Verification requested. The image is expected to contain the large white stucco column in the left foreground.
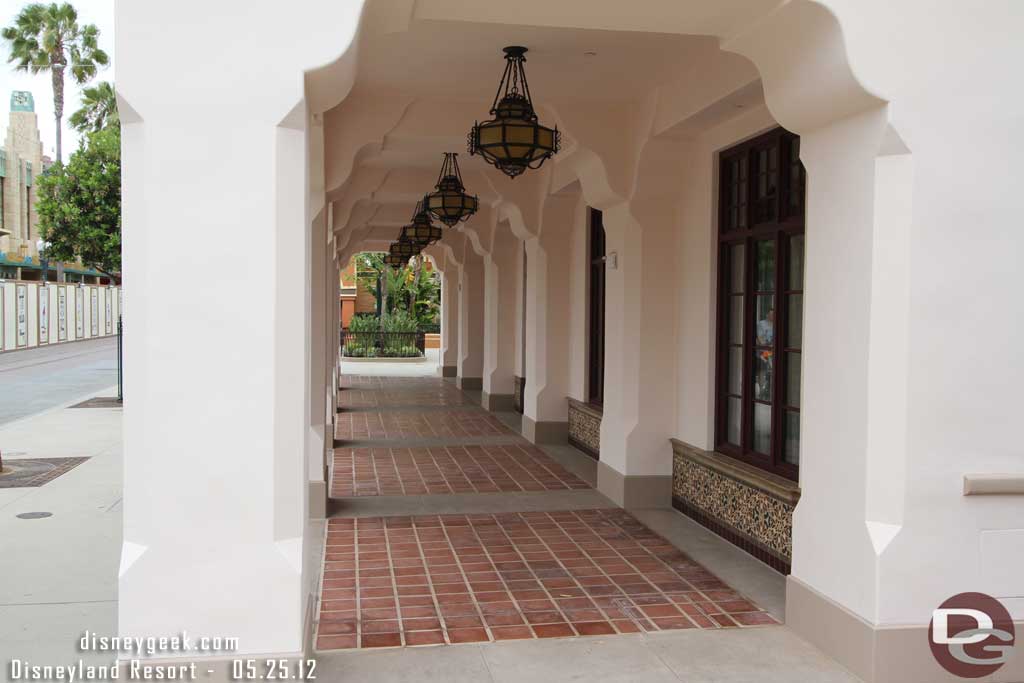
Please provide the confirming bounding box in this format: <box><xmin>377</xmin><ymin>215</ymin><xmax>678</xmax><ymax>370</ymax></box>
<box><xmin>116</xmin><ymin>0</ymin><xmax>358</xmax><ymax>656</ymax></box>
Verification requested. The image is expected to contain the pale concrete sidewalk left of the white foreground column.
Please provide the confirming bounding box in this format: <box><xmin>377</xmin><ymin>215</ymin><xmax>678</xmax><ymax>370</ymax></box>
<box><xmin>0</xmin><ymin>387</ymin><xmax>122</xmax><ymax>680</ymax></box>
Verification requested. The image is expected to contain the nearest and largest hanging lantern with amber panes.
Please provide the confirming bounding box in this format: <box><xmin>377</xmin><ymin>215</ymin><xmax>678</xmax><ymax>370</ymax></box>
<box><xmin>469</xmin><ymin>45</ymin><xmax>561</xmax><ymax>178</ymax></box>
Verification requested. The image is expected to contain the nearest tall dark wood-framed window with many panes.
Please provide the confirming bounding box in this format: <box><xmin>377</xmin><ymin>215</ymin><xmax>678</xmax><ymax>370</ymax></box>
<box><xmin>715</xmin><ymin>128</ymin><xmax>806</xmax><ymax>480</ymax></box>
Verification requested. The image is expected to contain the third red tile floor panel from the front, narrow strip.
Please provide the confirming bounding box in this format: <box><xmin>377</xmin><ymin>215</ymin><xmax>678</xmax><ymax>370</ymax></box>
<box><xmin>334</xmin><ymin>408</ymin><xmax>512</xmax><ymax>440</ymax></box>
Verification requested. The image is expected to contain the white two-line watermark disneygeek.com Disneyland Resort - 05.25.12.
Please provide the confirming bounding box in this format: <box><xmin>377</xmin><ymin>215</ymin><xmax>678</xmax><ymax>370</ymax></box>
<box><xmin>6</xmin><ymin>631</ymin><xmax>316</xmax><ymax>683</ymax></box>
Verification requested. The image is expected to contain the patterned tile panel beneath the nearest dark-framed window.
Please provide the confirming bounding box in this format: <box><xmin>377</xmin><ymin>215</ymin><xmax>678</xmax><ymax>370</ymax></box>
<box><xmin>671</xmin><ymin>440</ymin><xmax>800</xmax><ymax>573</ymax></box>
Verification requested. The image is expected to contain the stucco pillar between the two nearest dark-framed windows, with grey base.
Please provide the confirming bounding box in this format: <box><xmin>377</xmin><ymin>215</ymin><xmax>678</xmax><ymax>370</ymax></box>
<box><xmin>598</xmin><ymin>201</ymin><xmax>677</xmax><ymax>507</ymax></box>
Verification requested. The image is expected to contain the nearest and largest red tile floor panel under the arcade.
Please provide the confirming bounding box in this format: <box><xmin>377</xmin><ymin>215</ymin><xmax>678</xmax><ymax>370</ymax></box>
<box><xmin>316</xmin><ymin>509</ymin><xmax>776</xmax><ymax>650</ymax></box>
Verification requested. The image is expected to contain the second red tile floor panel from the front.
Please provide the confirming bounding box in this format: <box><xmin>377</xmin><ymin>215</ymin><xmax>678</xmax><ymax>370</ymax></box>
<box><xmin>331</xmin><ymin>443</ymin><xmax>590</xmax><ymax>498</ymax></box>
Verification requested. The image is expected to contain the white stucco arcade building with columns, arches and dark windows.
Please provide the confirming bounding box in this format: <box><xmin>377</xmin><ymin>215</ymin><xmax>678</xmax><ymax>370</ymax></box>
<box><xmin>117</xmin><ymin>0</ymin><xmax>1024</xmax><ymax>681</ymax></box>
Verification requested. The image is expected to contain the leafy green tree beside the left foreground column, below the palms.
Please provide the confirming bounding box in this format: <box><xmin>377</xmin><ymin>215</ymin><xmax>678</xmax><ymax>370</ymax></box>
<box><xmin>37</xmin><ymin>126</ymin><xmax>121</xmax><ymax>278</ymax></box>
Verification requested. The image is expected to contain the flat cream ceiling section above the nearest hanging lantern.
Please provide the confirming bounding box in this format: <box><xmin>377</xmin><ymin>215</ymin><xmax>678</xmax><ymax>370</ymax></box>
<box><xmin>356</xmin><ymin>20</ymin><xmax>718</xmax><ymax>102</ymax></box>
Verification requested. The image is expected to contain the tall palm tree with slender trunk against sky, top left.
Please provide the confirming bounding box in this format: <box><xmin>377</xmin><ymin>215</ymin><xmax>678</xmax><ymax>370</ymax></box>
<box><xmin>0</xmin><ymin>2</ymin><xmax>109</xmax><ymax>163</ymax></box>
